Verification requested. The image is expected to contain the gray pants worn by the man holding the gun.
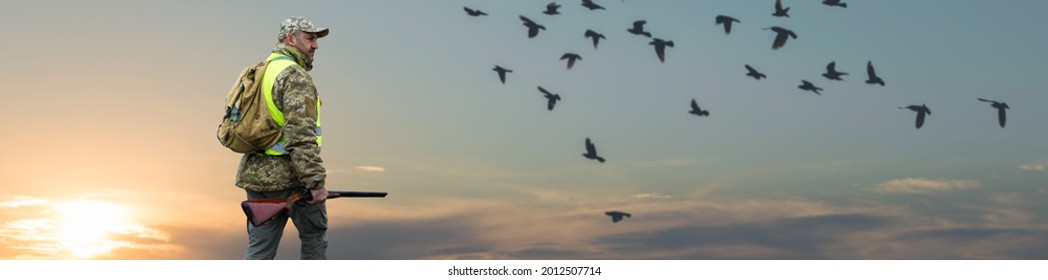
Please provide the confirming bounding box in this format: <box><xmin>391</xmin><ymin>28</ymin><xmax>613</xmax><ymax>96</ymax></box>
<box><xmin>244</xmin><ymin>190</ymin><xmax>327</xmax><ymax>260</ymax></box>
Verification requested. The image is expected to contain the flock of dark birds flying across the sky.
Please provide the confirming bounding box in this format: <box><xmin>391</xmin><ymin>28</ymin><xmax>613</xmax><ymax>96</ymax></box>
<box><xmin>463</xmin><ymin>0</ymin><xmax>1009</xmax><ymax>222</ymax></box>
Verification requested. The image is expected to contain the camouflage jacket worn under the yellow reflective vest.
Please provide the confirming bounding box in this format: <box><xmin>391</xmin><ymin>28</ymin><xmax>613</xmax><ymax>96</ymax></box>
<box><xmin>236</xmin><ymin>43</ymin><xmax>327</xmax><ymax>192</ymax></box>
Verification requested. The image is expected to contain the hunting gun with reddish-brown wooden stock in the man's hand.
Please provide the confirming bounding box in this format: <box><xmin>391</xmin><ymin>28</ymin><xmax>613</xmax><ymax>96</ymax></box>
<box><xmin>240</xmin><ymin>189</ymin><xmax>387</xmax><ymax>227</ymax></box>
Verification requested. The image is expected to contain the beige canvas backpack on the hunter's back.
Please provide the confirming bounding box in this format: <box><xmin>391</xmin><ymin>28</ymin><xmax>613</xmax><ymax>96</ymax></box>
<box><xmin>218</xmin><ymin>61</ymin><xmax>280</xmax><ymax>153</ymax></box>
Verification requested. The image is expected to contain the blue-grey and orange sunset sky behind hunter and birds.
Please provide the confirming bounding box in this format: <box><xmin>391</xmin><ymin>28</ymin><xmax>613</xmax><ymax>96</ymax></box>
<box><xmin>0</xmin><ymin>0</ymin><xmax>1048</xmax><ymax>260</ymax></box>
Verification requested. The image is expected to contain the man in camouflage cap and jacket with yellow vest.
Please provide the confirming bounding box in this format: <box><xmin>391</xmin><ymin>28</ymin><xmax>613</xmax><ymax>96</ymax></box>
<box><xmin>236</xmin><ymin>17</ymin><xmax>329</xmax><ymax>259</ymax></box>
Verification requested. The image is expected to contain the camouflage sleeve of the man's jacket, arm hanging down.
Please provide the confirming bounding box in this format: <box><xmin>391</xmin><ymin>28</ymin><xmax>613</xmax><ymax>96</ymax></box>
<box><xmin>277</xmin><ymin>66</ymin><xmax>327</xmax><ymax>188</ymax></box>
